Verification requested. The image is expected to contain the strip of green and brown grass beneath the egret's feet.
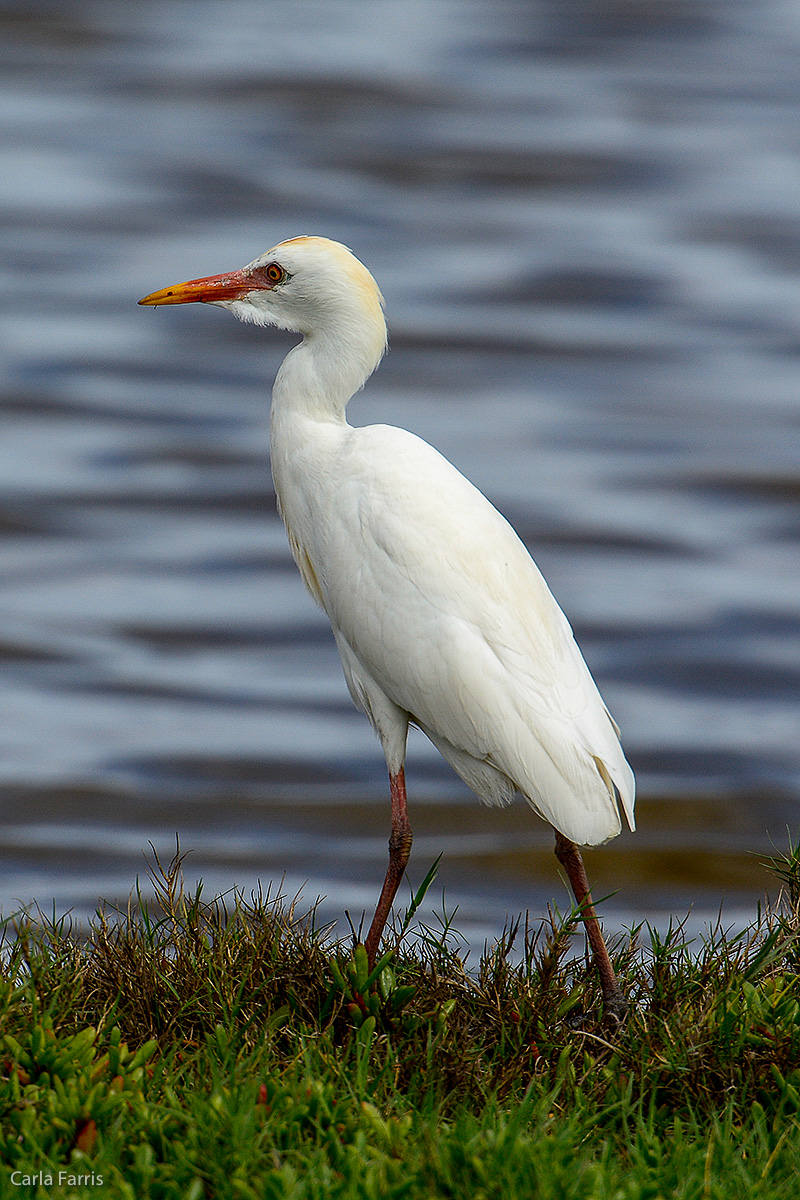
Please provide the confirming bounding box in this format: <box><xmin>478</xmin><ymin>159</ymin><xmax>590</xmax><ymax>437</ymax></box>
<box><xmin>0</xmin><ymin>852</ymin><xmax>800</xmax><ymax>1200</ymax></box>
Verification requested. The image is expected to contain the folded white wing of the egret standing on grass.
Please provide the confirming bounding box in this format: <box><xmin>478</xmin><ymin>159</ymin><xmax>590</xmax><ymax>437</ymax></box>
<box><xmin>309</xmin><ymin>426</ymin><xmax>632</xmax><ymax>842</ymax></box>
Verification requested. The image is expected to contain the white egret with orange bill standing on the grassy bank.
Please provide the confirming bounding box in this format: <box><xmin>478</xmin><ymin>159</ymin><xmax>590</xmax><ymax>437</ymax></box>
<box><xmin>139</xmin><ymin>238</ymin><xmax>634</xmax><ymax>1016</ymax></box>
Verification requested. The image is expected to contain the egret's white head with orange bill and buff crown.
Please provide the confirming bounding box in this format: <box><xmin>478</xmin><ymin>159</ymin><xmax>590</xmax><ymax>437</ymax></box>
<box><xmin>139</xmin><ymin>238</ymin><xmax>386</xmax><ymax>358</ymax></box>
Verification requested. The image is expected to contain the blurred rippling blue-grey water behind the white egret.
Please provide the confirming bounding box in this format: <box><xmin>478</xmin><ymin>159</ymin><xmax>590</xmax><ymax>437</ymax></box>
<box><xmin>0</xmin><ymin>0</ymin><xmax>800</xmax><ymax>947</ymax></box>
